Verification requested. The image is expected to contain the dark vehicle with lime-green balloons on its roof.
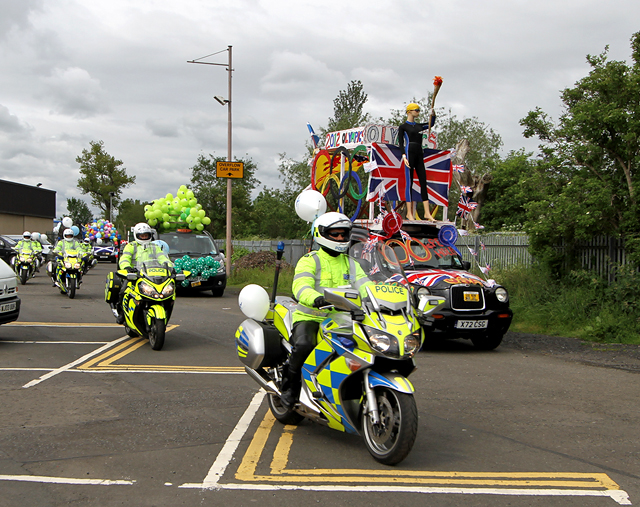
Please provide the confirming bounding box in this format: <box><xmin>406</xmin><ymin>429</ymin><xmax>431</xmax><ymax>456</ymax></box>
<box><xmin>158</xmin><ymin>229</ymin><xmax>227</xmax><ymax>297</ymax></box>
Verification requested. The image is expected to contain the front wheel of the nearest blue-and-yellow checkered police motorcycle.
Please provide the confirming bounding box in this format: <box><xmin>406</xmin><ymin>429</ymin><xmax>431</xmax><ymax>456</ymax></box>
<box><xmin>362</xmin><ymin>387</ymin><xmax>418</xmax><ymax>465</ymax></box>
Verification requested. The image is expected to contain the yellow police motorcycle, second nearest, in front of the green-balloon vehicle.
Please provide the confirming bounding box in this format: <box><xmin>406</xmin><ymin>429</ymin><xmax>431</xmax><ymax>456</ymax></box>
<box><xmin>105</xmin><ymin>259</ymin><xmax>190</xmax><ymax>350</ymax></box>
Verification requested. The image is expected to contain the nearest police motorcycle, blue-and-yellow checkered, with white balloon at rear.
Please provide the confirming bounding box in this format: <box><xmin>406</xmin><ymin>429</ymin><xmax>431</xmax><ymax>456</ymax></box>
<box><xmin>235</xmin><ymin>242</ymin><xmax>445</xmax><ymax>465</ymax></box>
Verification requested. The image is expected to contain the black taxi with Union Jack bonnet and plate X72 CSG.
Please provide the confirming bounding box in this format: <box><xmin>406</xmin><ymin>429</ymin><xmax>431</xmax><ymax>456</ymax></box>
<box><xmin>356</xmin><ymin>222</ymin><xmax>513</xmax><ymax>350</ymax></box>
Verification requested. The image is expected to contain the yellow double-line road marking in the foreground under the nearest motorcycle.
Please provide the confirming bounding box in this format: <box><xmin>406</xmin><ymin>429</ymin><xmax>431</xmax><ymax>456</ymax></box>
<box><xmin>236</xmin><ymin>412</ymin><xmax>620</xmax><ymax>490</ymax></box>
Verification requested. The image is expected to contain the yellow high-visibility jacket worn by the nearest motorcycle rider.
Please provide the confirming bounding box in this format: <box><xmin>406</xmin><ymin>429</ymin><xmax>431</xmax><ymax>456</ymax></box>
<box><xmin>292</xmin><ymin>249</ymin><xmax>373</xmax><ymax>324</ymax></box>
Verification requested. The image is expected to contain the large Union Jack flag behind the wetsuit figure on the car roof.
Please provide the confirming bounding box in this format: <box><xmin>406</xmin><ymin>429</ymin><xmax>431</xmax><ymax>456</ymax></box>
<box><xmin>367</xmin><ymin>143</ymin><xmax>451</xmax><ymax>206</ymax></box>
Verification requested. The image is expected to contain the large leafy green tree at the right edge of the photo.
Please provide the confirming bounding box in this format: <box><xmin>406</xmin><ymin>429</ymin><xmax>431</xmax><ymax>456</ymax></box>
<box><xmin>520</xmin><ymin>32</ymin><xmax>640</xmax><ymax>260</ymax></box>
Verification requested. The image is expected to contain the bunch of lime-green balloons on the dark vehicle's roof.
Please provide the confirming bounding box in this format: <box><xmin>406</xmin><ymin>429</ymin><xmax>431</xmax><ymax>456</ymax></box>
<box><xmin>144</xmin><ymin>185</ymin><xmax>211</xmax><ymax>232</ymax></box>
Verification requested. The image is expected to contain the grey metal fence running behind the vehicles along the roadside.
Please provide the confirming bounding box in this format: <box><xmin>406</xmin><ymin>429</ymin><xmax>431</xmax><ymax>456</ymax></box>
<box><xmin>224</xmin><ymin>232</ymin><xmax>628</xmax><ymax>277</ymax></box>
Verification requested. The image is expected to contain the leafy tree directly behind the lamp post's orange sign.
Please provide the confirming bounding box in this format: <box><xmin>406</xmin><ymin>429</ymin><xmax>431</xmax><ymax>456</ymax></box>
<box><xmin>191</xmin><ymin>155</ymin><xmax>260</xmax><ymax>238</ymax></box>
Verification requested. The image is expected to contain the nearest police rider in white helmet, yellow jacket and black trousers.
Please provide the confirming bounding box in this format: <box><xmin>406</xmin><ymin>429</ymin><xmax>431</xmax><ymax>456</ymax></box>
<box><xmin>281</xmin><ymin>212</ymin><xmax>371</xmax><ymax>409</ymax></box>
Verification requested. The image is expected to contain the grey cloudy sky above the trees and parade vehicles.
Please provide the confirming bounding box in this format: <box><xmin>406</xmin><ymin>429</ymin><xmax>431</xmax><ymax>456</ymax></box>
<box><xmin>0</xmin><ymin>0</ymin><xmax>640</xmax><ymax>214</ymax></box>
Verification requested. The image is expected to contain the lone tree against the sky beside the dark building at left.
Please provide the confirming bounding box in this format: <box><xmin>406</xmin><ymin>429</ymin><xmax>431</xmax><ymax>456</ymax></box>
<box><xmin>76</xmin><ymin>141</ymin><xmax>136</xmax><ymax>219</ymax></box>
